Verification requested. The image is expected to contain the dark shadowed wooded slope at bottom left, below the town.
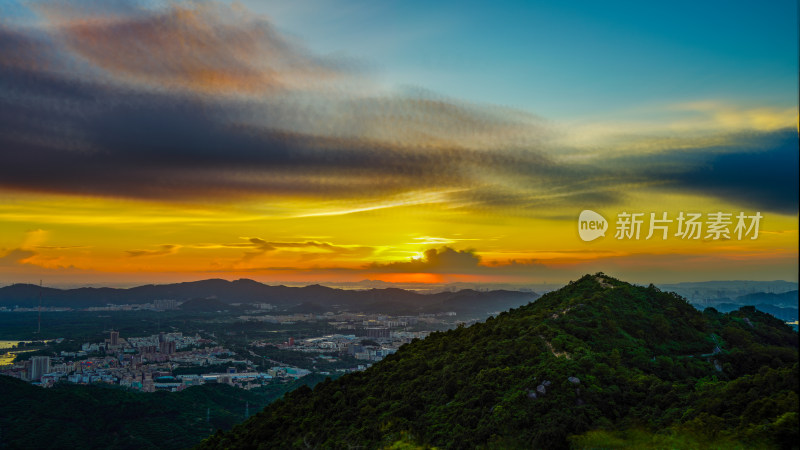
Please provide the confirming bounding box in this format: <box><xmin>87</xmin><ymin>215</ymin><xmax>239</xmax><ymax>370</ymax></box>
<box><xmin>0</xmin><ymin>375</ymin><xmax>328</xmax><ymax>449</ymax></box>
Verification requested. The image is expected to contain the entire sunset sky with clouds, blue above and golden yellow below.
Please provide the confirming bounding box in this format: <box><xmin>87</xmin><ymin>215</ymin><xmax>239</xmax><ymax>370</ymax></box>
<box><xmin>0</xmin><ymin>0</ymin><xmax>798</xmax><ymax>286</ymax></box>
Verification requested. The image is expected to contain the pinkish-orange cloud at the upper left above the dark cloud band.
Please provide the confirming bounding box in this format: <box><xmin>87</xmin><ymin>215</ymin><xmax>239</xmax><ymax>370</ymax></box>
<box><xmin>35</xmin><ymin>2</ymin><xmax>340</xmax><ymax>94</ymax></box>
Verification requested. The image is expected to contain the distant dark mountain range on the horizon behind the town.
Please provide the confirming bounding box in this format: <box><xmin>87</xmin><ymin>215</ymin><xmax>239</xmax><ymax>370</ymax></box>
<box><xmin>0</xmin><ymin>279</ymin><xmax>539</xmax><ymax>314</ymax></box>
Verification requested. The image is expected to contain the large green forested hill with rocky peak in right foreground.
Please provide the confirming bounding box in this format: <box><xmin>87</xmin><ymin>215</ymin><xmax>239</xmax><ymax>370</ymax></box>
<box><xmin>203</xmin><ymin>274</ymin><xmax>798</xmax><ymax>448</ymax></box>
